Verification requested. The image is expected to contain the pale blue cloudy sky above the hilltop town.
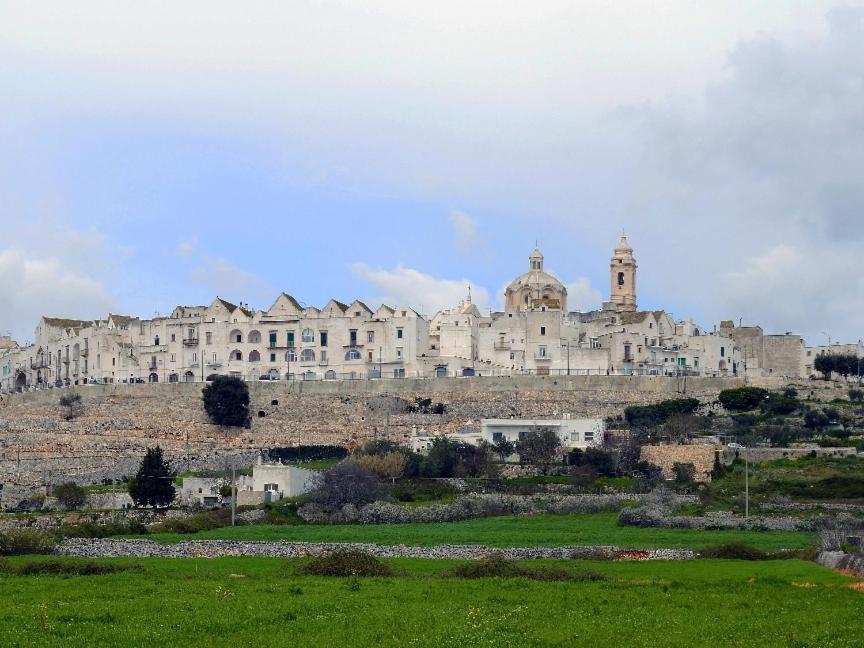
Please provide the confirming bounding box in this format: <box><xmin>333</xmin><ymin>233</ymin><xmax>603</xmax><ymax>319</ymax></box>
<box><xmin>0</xmin><ymin>0</ymin><xmax>864</xmax><ymax>344</ymax></box>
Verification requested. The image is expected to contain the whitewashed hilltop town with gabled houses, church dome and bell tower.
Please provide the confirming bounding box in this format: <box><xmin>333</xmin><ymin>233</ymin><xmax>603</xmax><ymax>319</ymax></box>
<box><xmin>0</xmin><ymin>236</ymin><xmax>858</xmax><ymax>392</ymax></box>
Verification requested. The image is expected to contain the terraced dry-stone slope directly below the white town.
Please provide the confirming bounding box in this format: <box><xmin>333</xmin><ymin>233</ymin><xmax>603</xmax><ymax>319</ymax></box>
<box><xmin>0</xmin><ymin>376</ymin><xmax>738</xmax><ymax>505</ymax></box>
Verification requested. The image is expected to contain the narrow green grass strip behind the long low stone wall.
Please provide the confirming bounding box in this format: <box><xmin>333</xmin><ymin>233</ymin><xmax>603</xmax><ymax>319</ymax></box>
<box><xmin>138</xmin><ymin>513</ymin><xmax>815</xmax><ymax>551</ymax></box>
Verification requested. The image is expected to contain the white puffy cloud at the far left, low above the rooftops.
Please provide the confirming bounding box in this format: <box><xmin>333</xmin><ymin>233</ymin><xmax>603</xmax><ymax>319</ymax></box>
<box><xmin>0</xmin><ymin>249</ymin><xmax>115</xmax><ymax>344</ymax></box>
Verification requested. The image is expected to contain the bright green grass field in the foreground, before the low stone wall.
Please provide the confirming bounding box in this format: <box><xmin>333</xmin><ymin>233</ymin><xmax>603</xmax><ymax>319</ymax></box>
<box><xmin>0</xmin><ymin>558</ymin><xmax>864</xmax><ymax>648</ymax></box>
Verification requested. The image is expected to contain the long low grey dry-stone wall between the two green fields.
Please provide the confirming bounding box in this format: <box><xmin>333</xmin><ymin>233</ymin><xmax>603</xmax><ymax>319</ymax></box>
<box><xmin>55</xmin><ymin>538</ymin><xmax>696</xmax><ymax>560</ymax></box>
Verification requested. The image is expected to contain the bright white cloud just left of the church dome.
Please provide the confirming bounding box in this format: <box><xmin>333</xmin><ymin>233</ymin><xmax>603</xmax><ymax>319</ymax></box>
<box><xmin>351</xmin><ymin>263</ymin><xmax>490</xmax><ymax>315</ymax></box>
